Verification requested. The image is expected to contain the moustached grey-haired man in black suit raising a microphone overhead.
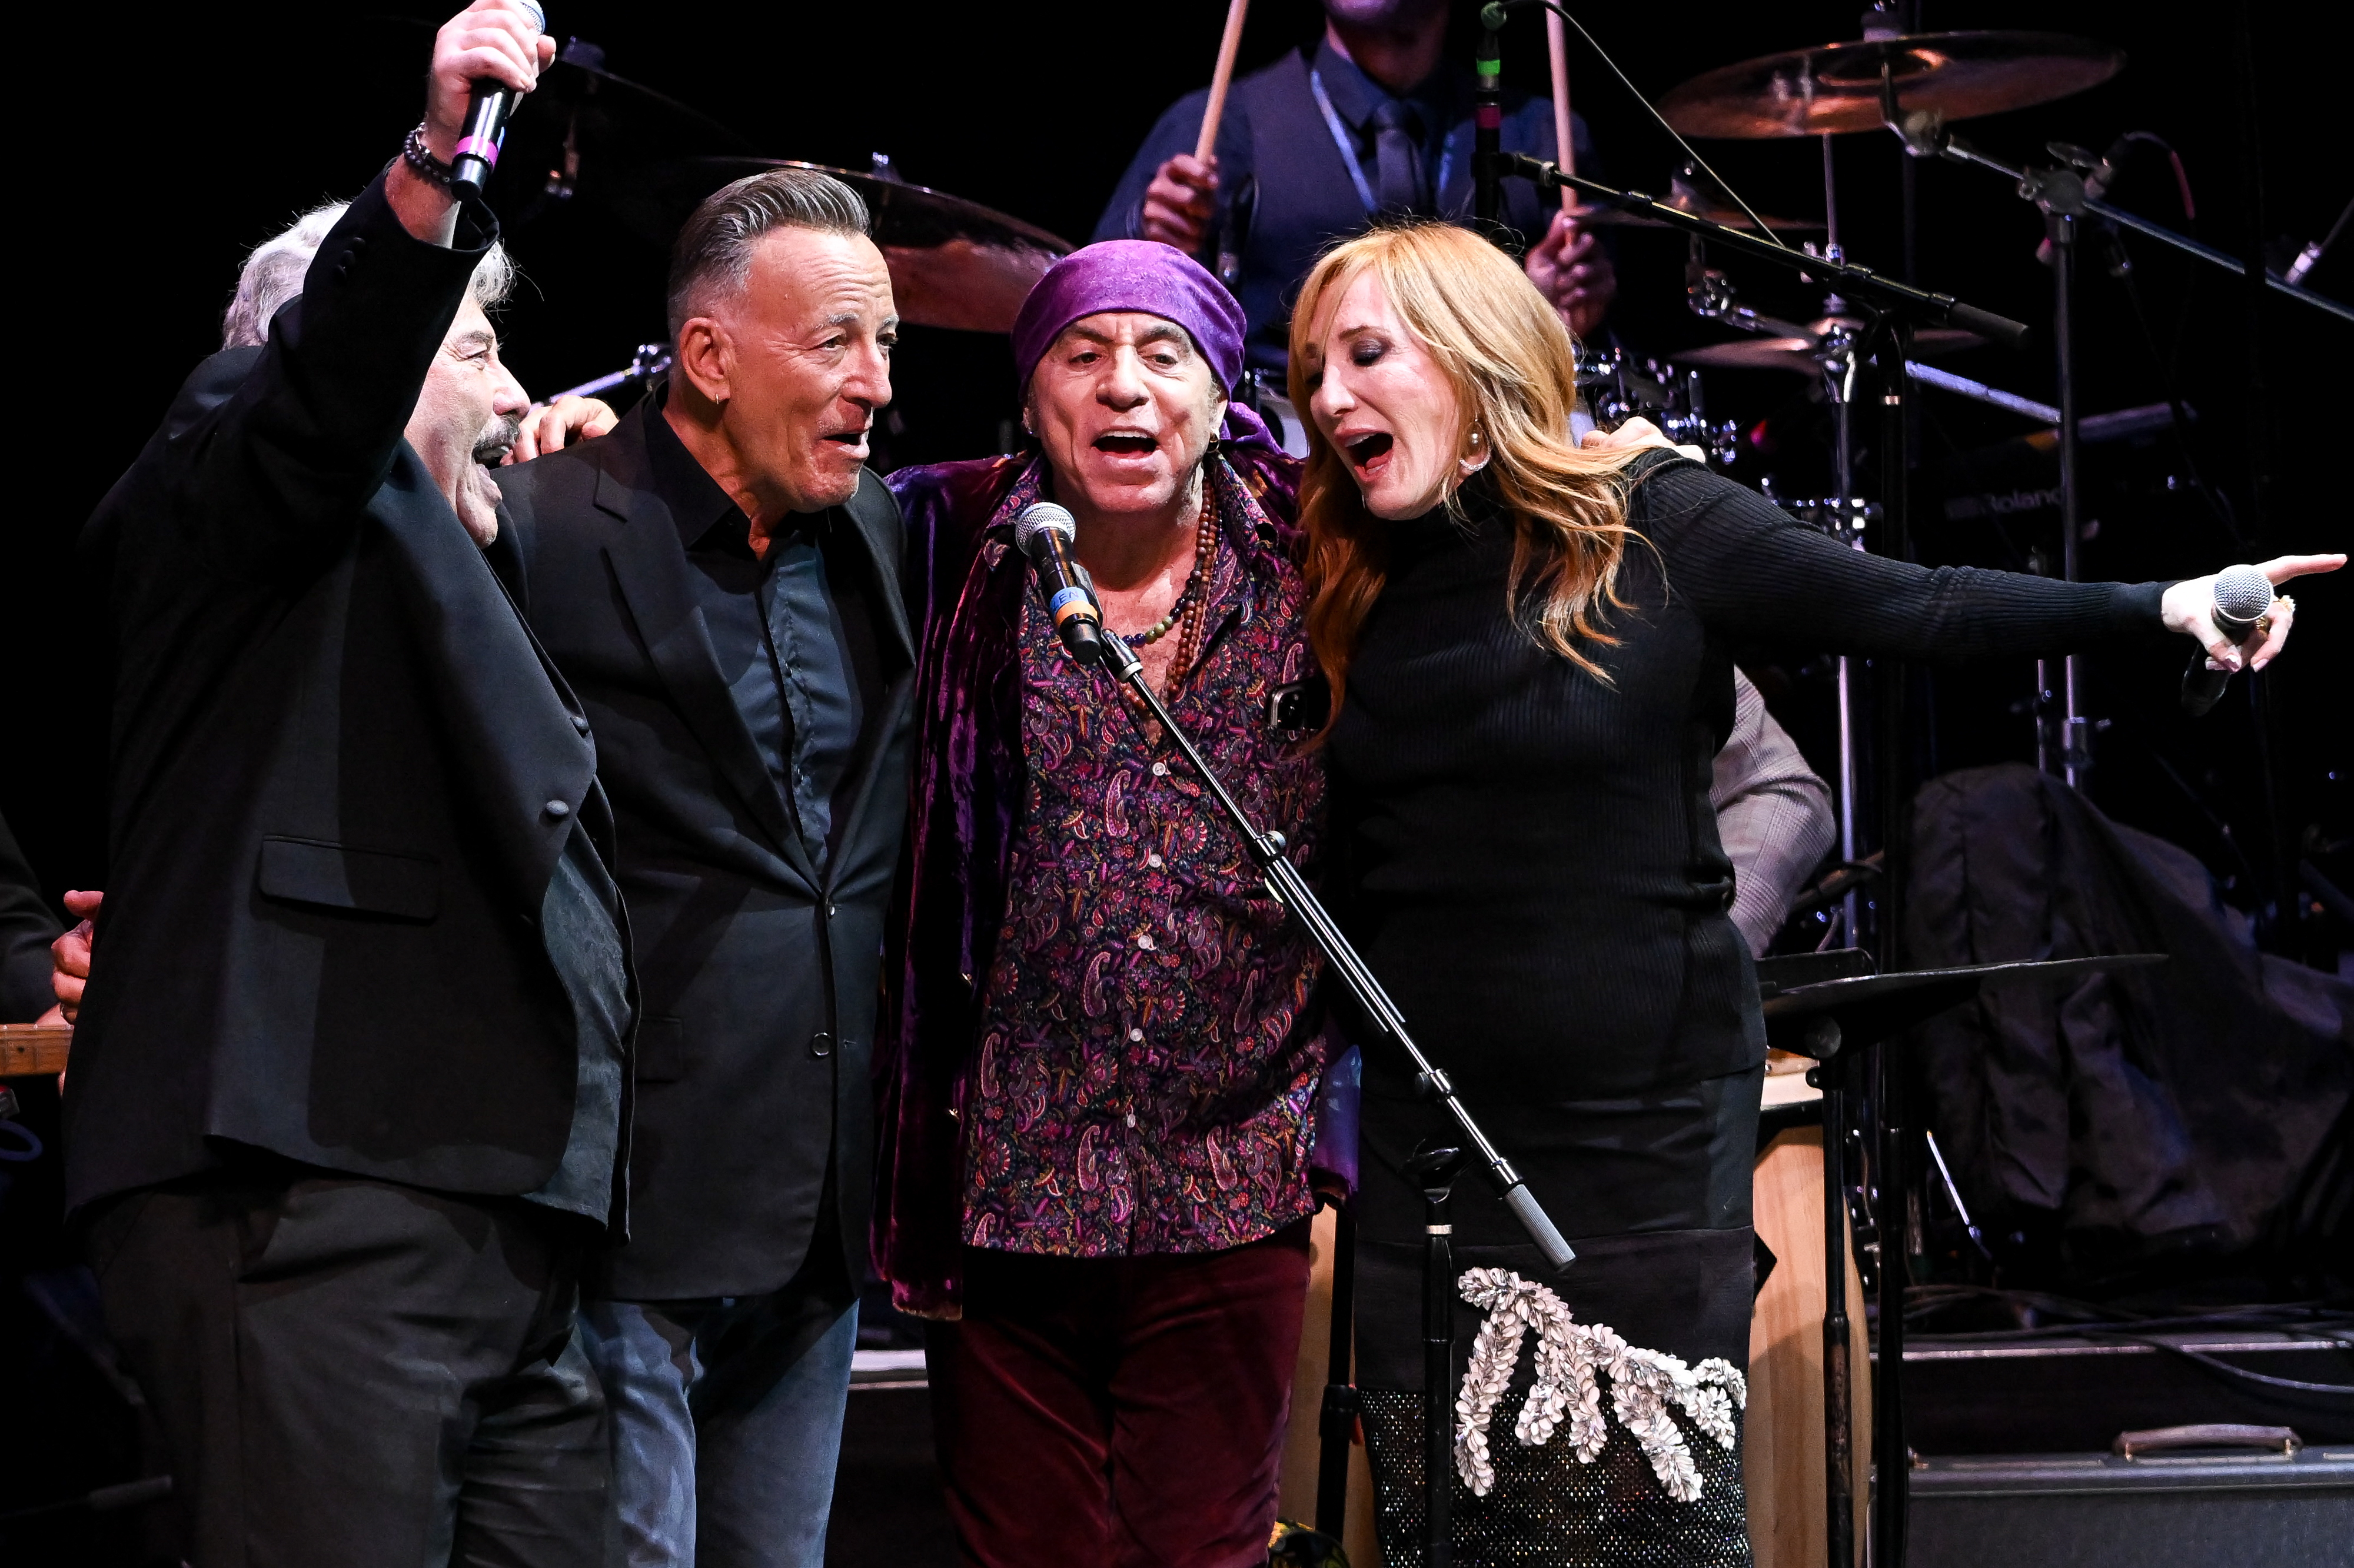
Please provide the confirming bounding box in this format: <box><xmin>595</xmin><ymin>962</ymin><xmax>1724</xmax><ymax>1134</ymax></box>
<box><xmin>66</xmin><ymin>0</ymin><xmax>631</xmax><ymax>1568</ymax></box>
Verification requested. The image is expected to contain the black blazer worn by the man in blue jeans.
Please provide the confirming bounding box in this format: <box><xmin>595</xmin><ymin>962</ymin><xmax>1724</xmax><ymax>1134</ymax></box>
<box><xmin>499</xmin><ymin>400</ymin><xmax>916</xmax><ymax>1300</ymax></box>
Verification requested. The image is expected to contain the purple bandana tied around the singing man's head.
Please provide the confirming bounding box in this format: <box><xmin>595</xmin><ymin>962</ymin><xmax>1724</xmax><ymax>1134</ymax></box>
<box><xmin>1015</xmin><ymin>240</ymin><xmax>1276</xmax><ymax>452</ymax></box>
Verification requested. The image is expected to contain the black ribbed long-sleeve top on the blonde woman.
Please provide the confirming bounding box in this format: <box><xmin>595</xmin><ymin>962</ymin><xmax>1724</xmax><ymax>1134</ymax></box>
<box><xmin>1330</xmin><ymin>457</ymin><xmax>2163</xmax><ymax>1243</ymax></box>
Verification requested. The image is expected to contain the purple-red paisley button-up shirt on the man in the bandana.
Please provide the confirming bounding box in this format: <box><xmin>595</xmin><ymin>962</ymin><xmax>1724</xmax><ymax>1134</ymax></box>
<box><xmin>963</xmin><ymin>464</ymin><xmax>1323</xmax><ymax>1257</ymax></box>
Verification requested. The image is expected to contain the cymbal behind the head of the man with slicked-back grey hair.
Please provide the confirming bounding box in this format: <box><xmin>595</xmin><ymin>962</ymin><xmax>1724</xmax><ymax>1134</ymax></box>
<box><xmin>607</xmin><ymin>158</ymin><xmax>1071</xmax><ymax>332</ymax></box>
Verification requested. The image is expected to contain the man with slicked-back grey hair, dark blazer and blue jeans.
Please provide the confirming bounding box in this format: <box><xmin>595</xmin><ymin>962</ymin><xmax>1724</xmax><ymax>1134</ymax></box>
<box><xmin>499</xmin><ymin>169</ymin><xmax>913</xmax><ymax>1568</ymax></box>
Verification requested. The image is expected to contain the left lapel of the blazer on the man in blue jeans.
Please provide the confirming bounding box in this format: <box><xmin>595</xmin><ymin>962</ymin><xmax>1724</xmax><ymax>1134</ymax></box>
<box><xmin>596</xmin><ymin>468</ymin><xmax>817</xmax><ymax>893</ymax></box>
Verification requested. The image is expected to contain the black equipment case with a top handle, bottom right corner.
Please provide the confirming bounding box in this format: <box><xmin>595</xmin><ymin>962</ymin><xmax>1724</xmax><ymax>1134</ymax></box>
<box><xmin>1904</xmin><ymin>1443</ymin><xmax>2354</xmax><ymax>1568</ymax></box>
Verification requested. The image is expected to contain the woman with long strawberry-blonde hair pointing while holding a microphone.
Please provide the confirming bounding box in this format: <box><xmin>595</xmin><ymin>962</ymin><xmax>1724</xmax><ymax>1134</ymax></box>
<box><xmin>1290</xmin><ymin>224</ymin><xmax>2345</xmax><ymax>1563</ymax></box>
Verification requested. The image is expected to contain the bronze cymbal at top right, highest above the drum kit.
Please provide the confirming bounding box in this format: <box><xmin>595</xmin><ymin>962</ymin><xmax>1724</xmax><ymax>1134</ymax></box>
<box><xmin>1660</xmin><ymin>33</ymin><xmax>2126</xmax><ymax>141</ymax></box>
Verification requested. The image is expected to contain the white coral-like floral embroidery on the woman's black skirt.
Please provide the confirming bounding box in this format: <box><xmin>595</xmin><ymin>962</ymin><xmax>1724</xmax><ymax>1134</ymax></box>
<box><xmin>1455</xmin><ymin>1269</ymin><xmax>1749</xmax><ymax>1502</ymax></box>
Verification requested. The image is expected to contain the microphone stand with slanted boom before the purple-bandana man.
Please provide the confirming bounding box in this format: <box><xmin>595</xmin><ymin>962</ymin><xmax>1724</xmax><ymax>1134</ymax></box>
<box><xmin>1102</xmin><ymin>628</ymin><xmax>1577</xmax><ymax>1568</ymax></box>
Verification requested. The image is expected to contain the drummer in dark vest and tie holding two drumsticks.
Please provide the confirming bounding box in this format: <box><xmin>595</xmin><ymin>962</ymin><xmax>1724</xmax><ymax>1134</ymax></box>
<box><xmin>1095</xmin><ymin>0</ymin><xmax>1617</xmax><ymax>386</ymax></box>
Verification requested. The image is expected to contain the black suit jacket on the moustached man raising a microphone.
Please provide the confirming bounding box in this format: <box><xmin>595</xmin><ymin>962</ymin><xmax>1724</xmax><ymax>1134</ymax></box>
<box><xmin>66</xmin><ymin>181</ymin><xmax>596</xmax><ymax>1206</ymax></box>
